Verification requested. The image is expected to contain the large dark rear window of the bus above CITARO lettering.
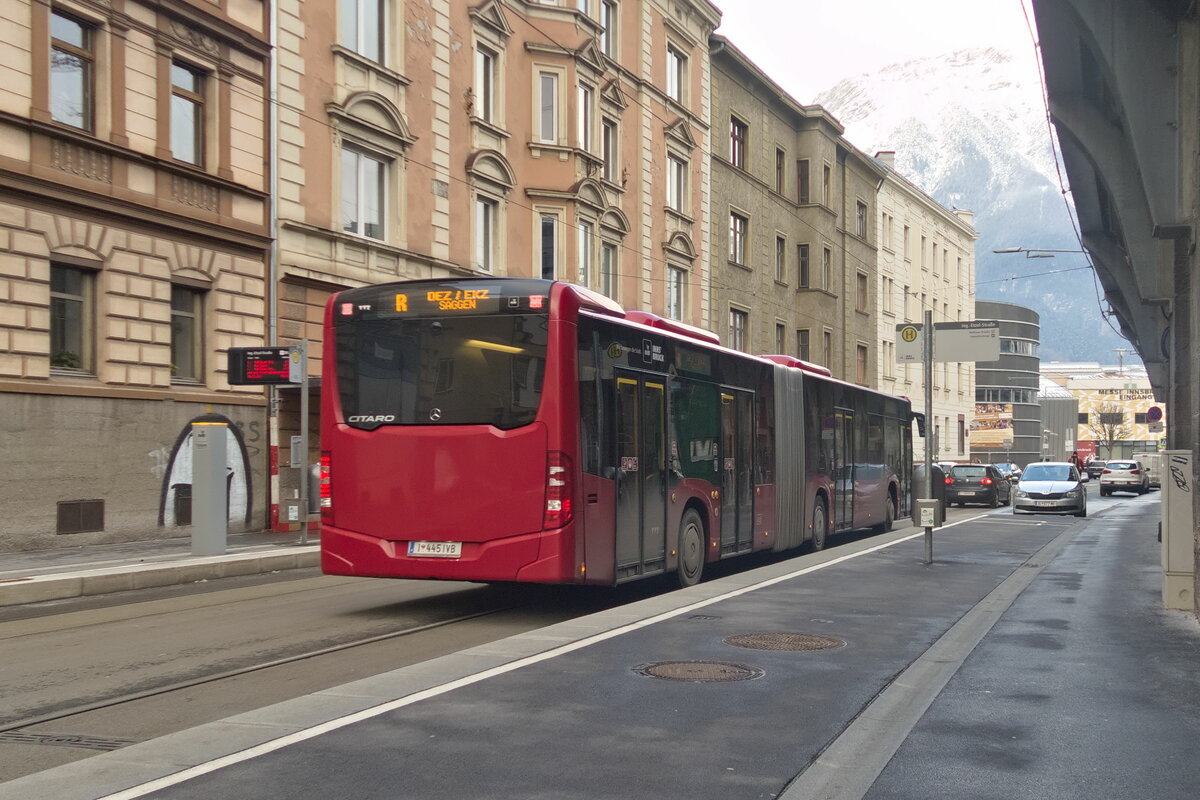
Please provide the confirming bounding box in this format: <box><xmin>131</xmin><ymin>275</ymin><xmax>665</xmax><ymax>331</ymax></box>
<box><xmin>336</xmin><ymin>313</ymin><xmax>548</xmax><ymax>429</ymax></box>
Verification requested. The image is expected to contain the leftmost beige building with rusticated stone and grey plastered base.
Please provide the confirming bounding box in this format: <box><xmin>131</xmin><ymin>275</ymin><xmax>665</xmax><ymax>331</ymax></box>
<box><xmin>0</xmin><ymin>0</ymin><xmax>269</xmax><ymax>549</ymax></box>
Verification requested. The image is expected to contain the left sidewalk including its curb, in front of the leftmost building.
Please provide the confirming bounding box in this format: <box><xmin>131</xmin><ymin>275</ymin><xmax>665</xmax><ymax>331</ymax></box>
<box><xmin>0</xmin><ymin>531</ymin><xmax>320</xmax><ymax>606</ymax></box>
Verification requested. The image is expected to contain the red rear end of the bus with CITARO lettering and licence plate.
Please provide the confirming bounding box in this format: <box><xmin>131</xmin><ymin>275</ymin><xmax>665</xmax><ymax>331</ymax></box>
<box><xmin>320</xmin><ymin>279</ymin><xmax>575</xmax><ymax>582</ymax></box>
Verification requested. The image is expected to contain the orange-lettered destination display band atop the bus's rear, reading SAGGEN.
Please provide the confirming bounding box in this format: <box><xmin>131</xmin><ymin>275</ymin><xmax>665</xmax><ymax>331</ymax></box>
<box><xmin>335</xmin><ymin>278</ymin><xmax>553</xmax><ymax>321</ymax></box>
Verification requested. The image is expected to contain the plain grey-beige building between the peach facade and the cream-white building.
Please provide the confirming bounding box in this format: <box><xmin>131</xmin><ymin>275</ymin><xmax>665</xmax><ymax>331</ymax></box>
<box><xmin>712</xmin><ymin>36</ymin><xmax>886</xmax><ymax>385</ymax></box>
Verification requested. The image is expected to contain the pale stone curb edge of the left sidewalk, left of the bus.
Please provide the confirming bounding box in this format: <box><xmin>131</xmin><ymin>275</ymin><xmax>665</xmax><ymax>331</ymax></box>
<box><xmin>0</xmin><ymin>545</ymin><xmax>320</xmax><ymax>607</ymax></box>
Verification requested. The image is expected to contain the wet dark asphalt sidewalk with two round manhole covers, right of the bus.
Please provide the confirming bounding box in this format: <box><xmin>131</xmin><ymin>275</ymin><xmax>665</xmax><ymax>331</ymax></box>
<box><xmin>0</xmin><ymin>498</ymin><xmax>1200</xmax><ymax>800</ymax></box>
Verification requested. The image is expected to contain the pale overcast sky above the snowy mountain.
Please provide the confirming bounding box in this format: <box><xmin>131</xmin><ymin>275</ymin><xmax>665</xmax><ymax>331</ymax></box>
<box><xmin>715</xmin><ymin>0</ymin><xmax>1033</xmax><ymax>103</ymax></box>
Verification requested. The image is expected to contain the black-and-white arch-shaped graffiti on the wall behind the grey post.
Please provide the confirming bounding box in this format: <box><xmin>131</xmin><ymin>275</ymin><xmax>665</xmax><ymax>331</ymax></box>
<box><xmin>157</xmin><ymin>414</ymin><xmax>253</xmax><ymax>528</ymax></box>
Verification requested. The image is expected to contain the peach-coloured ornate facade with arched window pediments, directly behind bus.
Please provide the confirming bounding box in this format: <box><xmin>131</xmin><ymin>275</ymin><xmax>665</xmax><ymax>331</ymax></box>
<box><xmin>274</xmin><ymin>0</ymin><xmax>720</xmax><ymax>527</ymax></box>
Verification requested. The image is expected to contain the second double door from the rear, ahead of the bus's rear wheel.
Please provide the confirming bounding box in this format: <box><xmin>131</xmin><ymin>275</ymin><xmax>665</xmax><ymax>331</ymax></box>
<box><xmin>721</xmin><ymin>390</ymin><xmax>754</xmax><ymax>553</ymax></box>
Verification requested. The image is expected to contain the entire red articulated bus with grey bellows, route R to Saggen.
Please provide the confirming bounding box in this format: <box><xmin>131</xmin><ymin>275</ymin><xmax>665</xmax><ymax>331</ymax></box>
<box><xmin>320</xmin><ymin>278</ymin><xmax>912</xmax><ymax>585</ymax></box>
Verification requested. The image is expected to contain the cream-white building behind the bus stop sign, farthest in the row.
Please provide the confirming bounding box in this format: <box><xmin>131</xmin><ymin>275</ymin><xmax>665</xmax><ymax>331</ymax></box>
<box><xmin>875</xmin><ymin>152</ymin><xmax>979</xmax><ymax>461</ymax></box>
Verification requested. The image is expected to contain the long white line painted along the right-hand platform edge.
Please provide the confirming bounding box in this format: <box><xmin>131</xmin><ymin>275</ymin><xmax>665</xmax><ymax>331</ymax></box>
<box><xmin>98</xmin><ymin>515</ymin><xmax>986</xmax><ymax>800</ymax></box>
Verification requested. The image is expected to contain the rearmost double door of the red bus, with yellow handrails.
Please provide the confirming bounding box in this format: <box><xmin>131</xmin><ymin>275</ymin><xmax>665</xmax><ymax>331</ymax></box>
<box><xmin>616</xmin><ymin>375</ymin><xmax>667</xmax><ymax>581</ymax></box>
